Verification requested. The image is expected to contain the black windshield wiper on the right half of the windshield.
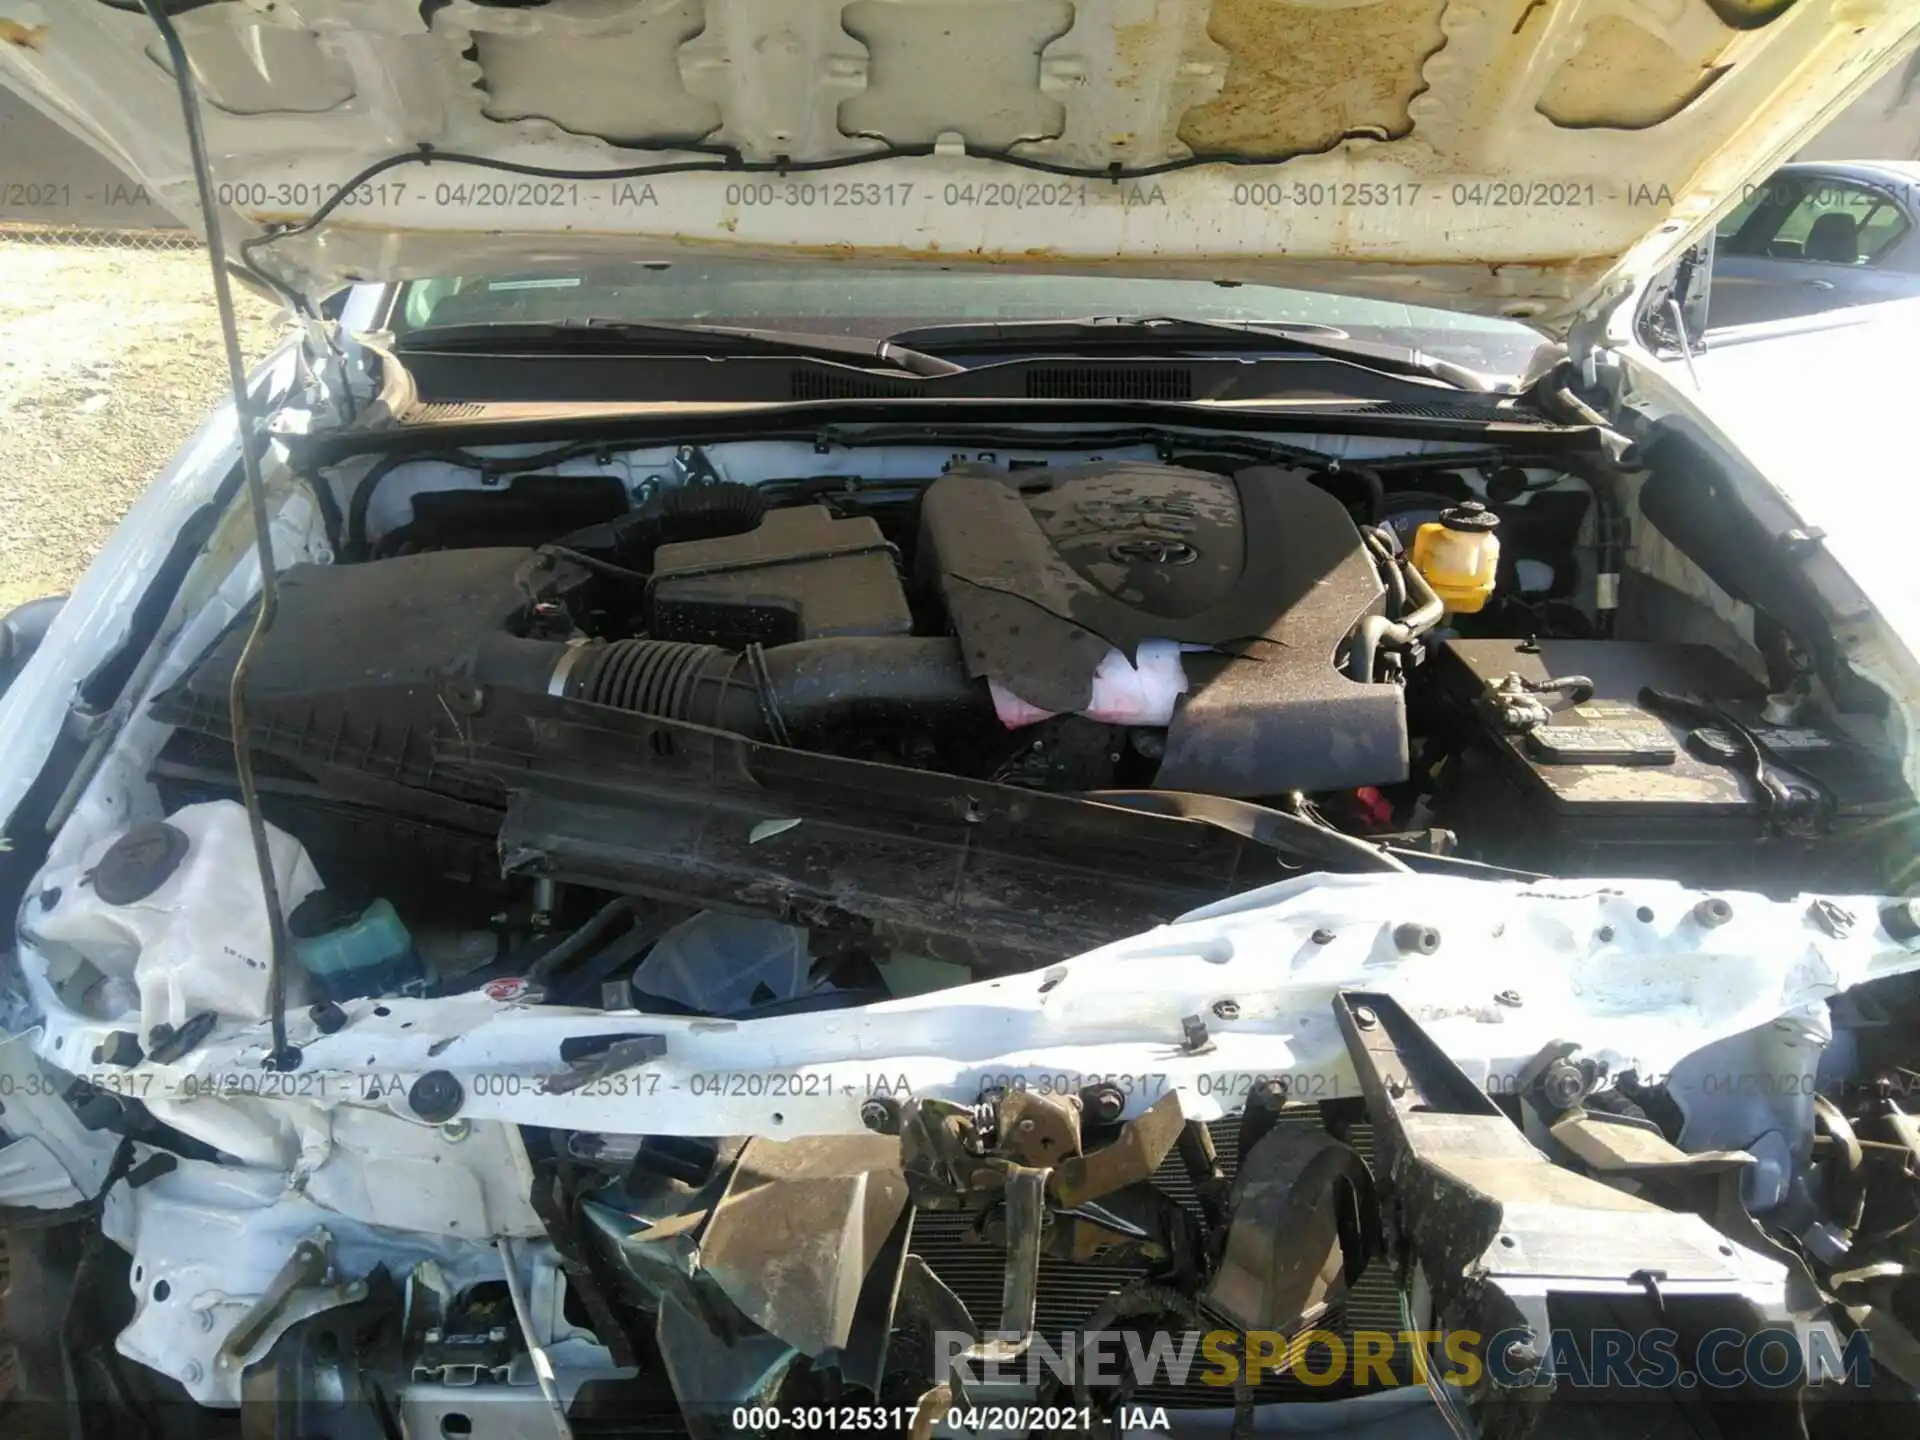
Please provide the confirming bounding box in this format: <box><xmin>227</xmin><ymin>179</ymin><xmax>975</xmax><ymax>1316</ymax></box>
<box><xmin>887</xmin><ymin>315</ymin><xmax>1494</xmax><ymax>392</ymax></box>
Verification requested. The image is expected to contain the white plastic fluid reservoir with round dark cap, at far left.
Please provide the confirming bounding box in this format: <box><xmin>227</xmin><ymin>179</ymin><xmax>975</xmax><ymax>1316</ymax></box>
<box><xmin>23</xmin><ymin>801</ymin><xmax>321</xmax><ymax>1035</ymax></box>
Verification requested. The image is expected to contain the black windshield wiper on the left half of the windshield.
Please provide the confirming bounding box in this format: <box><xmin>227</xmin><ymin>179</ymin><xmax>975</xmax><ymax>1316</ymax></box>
<box><xmin>396</xmin><ymin>319</ymin><xmax>966</xmax><ymax>376</ymax></box>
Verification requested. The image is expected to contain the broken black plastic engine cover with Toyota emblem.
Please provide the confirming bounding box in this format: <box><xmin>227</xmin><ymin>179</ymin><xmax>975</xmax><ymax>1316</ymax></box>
<box><xmin>920</xmin><ymin>461</ymin><xmax>1407</xmax><ymax>795</ymax></box>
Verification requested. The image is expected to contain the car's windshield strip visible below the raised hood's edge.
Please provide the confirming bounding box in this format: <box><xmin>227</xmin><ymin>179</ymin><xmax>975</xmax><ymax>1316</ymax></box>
<box><xmin>392</xmin><ymin>261</ymin><xmax>1542</xmax><ymax>376</ymax></box>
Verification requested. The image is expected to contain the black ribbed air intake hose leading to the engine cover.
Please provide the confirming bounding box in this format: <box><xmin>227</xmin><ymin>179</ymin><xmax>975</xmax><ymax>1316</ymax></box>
<box><xmin>547</xmin><ymin>636</ymin><xmax>993</xmax><ymax>743</ymax></box>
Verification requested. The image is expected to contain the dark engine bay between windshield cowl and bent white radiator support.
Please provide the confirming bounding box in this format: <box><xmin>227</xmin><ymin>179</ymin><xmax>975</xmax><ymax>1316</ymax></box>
<box><xmin>127</xmin><ymin>433</ymin><xmax>1905</xmax><ymax>1002</ymax></box>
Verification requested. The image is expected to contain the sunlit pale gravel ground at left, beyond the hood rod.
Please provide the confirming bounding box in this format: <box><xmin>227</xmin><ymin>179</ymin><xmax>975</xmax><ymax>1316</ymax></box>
<box><xmin>0</xmin><ymin>240</ymin><xmax>280</xmax><ymax>609</ymax></box>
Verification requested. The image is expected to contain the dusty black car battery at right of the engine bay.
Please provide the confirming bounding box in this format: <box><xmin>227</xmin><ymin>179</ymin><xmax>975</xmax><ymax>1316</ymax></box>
<box><xmin>1428</xmin><ymin>639</ymin><xmax>1912</xmax><ymax>889</ymax></box>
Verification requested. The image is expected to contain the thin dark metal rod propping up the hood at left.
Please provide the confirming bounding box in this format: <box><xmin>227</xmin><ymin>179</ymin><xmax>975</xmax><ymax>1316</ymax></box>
<box><xmin>140</xmin><ymin>0</ymin><xmax>300</xmax><ymax>1069</ymax></box>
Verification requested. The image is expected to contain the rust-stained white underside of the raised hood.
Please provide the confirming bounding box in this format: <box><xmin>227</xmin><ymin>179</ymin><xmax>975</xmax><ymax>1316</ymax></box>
<box><xmin>0</xmin><ymin>0</ymin><xmax>1916</xmax><ymax>332</ymax></box>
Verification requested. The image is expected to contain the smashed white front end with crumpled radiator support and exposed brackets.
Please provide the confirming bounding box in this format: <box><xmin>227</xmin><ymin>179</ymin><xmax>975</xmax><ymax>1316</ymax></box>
<box><xmin>0</xmin><ymin>840</ymin><xmax>1920</xmax><ymax>1440</ymax></box>
